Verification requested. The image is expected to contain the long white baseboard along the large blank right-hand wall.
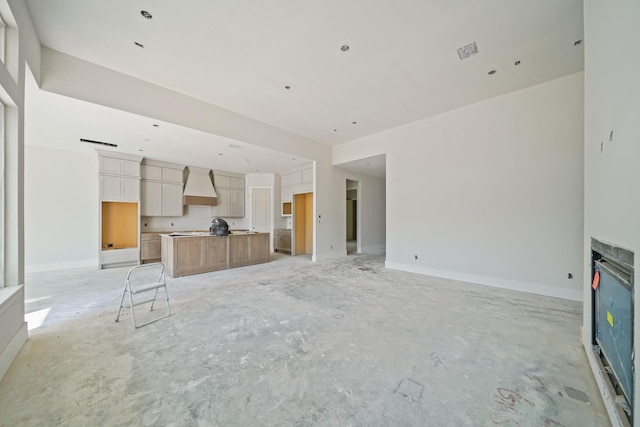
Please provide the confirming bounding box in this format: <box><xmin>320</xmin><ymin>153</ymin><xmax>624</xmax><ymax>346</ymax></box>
<box><xmin>384</xmin><ymin>261</ymin><xmax>583</xmax><ymax>302</ymax></box>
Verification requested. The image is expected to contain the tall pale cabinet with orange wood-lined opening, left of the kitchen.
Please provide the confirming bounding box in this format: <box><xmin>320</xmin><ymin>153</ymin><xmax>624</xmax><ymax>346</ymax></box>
<box><xmin>96</xmin><ymin>150</ymin><xmax>142</xmax><ymax>268</ymax></box>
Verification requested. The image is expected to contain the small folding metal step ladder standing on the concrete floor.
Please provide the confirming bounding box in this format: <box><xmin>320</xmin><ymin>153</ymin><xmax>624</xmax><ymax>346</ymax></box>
<box><xmin>116</xmin><ymin>262</ymin><xmax>171</xmax><ymax>329</ymax></box>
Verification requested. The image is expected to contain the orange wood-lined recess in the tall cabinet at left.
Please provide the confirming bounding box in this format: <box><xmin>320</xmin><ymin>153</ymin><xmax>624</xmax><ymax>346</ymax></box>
<box><xmin>102</xmin><ymin>202</ymin><xmax>138</xmax><ymax>248</ymax></box>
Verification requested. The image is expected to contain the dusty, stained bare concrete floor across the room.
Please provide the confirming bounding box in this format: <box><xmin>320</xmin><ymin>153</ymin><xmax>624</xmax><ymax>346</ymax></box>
<box><xmin>0</xmin><ymin>254</ymin><xmax>609</xmax><ymax>427</ymax></box>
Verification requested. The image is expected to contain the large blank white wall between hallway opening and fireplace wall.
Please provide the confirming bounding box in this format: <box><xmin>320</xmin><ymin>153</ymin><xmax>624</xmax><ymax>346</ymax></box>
<box><xmin>334</xmin><ymin>73</ymin><xmax>583</xmax><ymax>300</ymax></box>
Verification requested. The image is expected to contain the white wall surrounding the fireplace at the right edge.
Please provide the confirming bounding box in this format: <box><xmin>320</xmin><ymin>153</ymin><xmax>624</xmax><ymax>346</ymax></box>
<box><xmin>583</xmin><ymin>0</ymin><xmax>640</xmax><ymax>425</ymax></box>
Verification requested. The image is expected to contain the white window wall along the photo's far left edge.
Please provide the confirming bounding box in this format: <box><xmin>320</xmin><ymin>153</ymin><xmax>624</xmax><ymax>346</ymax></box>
<box><xmin>0</xmin><ymin>0</ymin><xmax>40</xmax><ymax>379</ymax></box>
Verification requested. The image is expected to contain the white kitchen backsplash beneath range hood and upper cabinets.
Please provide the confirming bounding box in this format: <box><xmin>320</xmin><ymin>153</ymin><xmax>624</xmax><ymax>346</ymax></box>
<box><xmin>140</xmin><ymin>205</ymin><xmax>249</xmax><ymax>232</ymax></box>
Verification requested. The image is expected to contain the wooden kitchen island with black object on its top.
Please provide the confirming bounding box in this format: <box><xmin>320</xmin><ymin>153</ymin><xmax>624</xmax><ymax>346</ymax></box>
<box><xmin>160</xmin><ymin>231</ymin><xmax>269</xmax><ymax>277</ymax></box>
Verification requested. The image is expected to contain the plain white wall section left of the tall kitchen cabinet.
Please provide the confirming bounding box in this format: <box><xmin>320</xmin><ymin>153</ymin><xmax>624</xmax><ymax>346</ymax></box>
<box><xmin>24</xmin><ymin>145</ymin><xmax>99</xmax><ymax>272</ymax></box>
